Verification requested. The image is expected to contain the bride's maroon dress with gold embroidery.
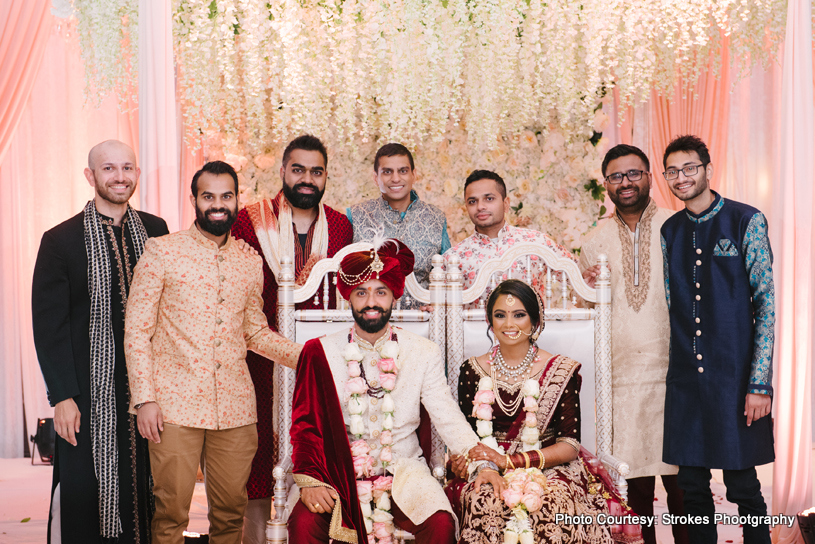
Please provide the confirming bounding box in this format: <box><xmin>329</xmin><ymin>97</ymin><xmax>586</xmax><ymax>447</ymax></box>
<box><xmin>445</xmin><ymin>355</ymin><xmax>642</xmax><ymax>544</ymax></box>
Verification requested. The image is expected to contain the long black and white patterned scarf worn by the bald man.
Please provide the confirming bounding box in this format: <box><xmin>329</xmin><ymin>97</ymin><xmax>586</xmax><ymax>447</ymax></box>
<box><xmin>85</xmin><ymin>200</ymin><xmax>147</xmax><ymax>538</ymax></box>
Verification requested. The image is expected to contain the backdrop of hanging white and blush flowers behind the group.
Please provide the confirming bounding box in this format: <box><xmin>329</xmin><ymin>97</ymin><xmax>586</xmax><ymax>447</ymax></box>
<box><xmin>62</xmin><ymin>0</ymin><xmax>792</xmax><ymax>250</ymax></box>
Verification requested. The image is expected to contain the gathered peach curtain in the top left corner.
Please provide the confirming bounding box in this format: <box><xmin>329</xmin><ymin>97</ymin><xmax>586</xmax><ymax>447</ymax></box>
<box><xmin>0</xmin><ymin>0</ymin><xmax>52</xmax><ymax>163</ymax></box>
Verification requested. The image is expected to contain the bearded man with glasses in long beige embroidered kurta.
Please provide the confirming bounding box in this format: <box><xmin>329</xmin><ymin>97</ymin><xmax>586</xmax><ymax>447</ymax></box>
<box><xmin>580</xmin><ymin>145</ymin><xmax>688</xmax><ymax>544</ymax></box>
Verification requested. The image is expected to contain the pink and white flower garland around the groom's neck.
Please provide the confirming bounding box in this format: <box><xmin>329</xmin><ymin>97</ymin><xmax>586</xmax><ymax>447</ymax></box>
<box><xmin>343</xmin><ymin>329</ymin><xmax>399</xmax><ymax>544</ymax></box>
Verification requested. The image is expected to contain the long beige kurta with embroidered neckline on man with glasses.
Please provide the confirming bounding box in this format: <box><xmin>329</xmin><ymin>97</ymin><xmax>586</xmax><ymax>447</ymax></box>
<box><xmin>580</xmin><ymin>200</ymin><xmax>677</xmax><ymax>478</ymax></box>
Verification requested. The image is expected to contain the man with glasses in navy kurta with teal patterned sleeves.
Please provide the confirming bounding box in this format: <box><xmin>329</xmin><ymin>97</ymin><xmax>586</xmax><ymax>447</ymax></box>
<box><xmin>662</xmin><ymin>136</ymin><xmax>775</xmax><ymax>544</ymax></box>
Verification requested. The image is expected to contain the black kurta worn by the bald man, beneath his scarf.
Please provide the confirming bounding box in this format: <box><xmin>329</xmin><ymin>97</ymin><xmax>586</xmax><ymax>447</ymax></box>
<box><xmin>32</xmin><ymin>206</ymin><xmax>168</xmax><ymax>544</ymax></box>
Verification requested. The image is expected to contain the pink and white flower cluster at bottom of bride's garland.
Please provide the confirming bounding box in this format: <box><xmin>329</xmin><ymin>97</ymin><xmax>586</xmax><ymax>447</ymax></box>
<box><xmin>501</xmin><ymin>468</ymin><xmax>547</xmax><ymax>544</ymax></box>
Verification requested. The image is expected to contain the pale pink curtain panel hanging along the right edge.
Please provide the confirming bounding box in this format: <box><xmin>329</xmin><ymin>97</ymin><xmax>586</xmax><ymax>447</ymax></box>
<box><xmin>773</xmin><ymin>0</ymin><xmax>815</xmax><ymax>544</ymax></box>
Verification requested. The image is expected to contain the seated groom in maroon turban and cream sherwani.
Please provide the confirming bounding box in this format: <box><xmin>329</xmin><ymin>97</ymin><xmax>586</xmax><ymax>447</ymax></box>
<box><xmin>289</xmin><ymin>240</ymin><xmax>504</xmax><ymax>544</ymax></box>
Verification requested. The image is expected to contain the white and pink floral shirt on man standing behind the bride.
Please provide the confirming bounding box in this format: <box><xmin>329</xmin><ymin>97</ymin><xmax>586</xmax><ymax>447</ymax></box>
<box><xmin>444</xmin><ymin>223</ymin><xmax>577</xmax><ymax>291</ymax></box>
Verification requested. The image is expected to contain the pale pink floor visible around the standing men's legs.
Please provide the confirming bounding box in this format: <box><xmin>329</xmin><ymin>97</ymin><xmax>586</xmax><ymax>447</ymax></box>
<box><xmin>0</xmin><ymin>459</ymin><xmax>804</xmax><ymax>544</ymax></box>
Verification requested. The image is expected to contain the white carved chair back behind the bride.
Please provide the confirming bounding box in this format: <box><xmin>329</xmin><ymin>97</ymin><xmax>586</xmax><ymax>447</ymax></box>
<box><xmin>446</xmin><ymin>244</ymin><xmax>611</xmax><ymax>454</ymax></box>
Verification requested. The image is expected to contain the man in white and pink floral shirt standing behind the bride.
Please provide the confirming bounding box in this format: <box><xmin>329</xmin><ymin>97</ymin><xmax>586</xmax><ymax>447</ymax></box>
<box><xmin>444</xmin><ymin>170</ymin><xmax>577</xmax><ymax>291</ymax></box>
